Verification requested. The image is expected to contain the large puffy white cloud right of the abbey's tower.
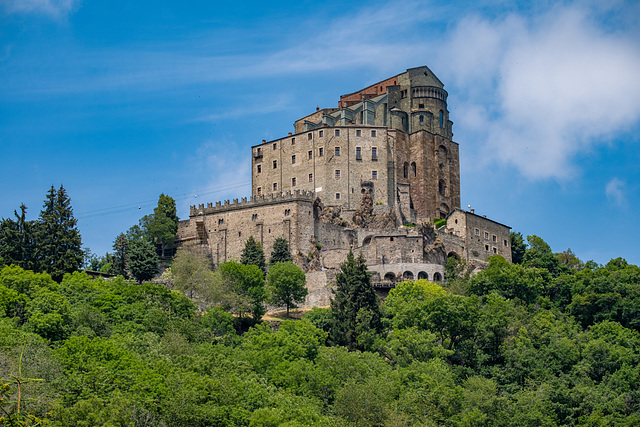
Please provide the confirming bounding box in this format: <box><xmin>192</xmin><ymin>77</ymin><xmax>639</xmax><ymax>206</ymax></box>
<box><xmin>442</xmin><ymin>3</ymin><xmax>640</xmax><ymax>179</ymax></box>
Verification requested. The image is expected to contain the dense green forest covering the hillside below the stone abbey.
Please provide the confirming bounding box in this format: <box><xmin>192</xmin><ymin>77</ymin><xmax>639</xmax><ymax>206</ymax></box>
<box><xmin>0</xmin><ymin>189</ymin><xmax>640</xmax><ymax>426</ymax></box>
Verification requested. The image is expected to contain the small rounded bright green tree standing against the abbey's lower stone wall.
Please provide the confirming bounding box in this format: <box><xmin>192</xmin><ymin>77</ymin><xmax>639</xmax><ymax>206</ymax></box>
<box><xmin>267</xmin><ymin>260</ymin><xmax>308</xmax><ymax>317</ymax></box>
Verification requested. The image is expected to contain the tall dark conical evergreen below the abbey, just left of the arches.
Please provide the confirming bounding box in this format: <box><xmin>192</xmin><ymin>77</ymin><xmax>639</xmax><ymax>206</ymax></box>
<box><xmin>329</xmin><ymin>251</ymin><xmax>382</xmax><ymax>349</ymax></box>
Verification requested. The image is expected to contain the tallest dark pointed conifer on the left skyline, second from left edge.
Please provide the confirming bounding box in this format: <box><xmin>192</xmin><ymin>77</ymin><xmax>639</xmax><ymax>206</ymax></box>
<box><xmin>36</xmin><ymin>185</ymin><xmax>84</xmax><ymax>282</ymax></box>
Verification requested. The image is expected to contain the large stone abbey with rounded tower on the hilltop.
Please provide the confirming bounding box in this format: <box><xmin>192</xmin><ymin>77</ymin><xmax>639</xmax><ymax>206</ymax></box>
<box><xmin>177</xmin><ymin>66</ymin><xmax>511</xmax><ymax>305</ymax></box>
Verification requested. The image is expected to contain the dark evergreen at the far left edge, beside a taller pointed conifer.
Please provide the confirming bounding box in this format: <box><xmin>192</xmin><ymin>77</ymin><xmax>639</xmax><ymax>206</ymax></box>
<box><xmin>0</xmin><ymin>204</ymin><xmax>39</xmax><ymax>271</ymax></box>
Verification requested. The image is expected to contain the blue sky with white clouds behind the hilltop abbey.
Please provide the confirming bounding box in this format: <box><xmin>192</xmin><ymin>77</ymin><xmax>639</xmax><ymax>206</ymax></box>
<box><xmin>0</xmin><ymin>0</ymin><xmax>640</xmax><ymax>264</ymax></box>
